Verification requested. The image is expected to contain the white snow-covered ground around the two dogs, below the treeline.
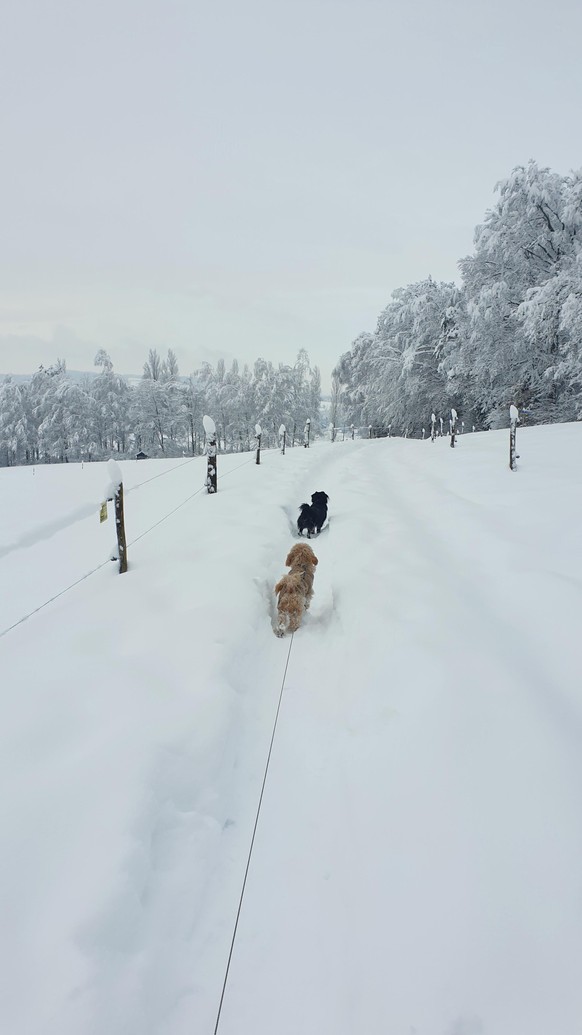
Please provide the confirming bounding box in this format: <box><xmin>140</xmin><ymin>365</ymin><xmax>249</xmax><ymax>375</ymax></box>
<box><xmin>0</xmin><ymin>425</ymin><xmax>582</xmax><ymax>1035</ymax></box>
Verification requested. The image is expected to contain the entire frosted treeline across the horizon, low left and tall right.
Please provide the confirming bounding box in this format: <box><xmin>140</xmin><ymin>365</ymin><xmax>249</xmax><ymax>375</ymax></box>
<box><xmin>0</xmin><ymin>161</ymin><xmax>582</xmax><ymax>466</ymax></box>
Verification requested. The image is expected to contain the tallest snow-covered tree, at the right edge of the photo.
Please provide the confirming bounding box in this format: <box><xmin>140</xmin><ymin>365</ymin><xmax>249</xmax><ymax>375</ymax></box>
<box><xmin>460</xmin><ymin>161</ymin><xmax>580</xmax><ymax>425</ymax></box>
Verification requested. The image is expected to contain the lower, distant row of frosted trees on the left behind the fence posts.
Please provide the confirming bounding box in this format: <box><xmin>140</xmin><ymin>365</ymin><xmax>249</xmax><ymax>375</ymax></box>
<box><xmin>0</xmin><ymin>349</ymin><xmax>321</xmax><ymax>466</ymax></box>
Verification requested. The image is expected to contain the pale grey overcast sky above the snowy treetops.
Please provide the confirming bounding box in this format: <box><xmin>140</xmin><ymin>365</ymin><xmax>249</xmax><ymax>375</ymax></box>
<box><xmin>0</xmin><ymin>0</ymin><xmax>582</xmax><ymax>388</ymax></box>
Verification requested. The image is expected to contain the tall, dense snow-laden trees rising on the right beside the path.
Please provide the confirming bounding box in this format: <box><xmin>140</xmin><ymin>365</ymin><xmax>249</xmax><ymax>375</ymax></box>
<box><xmin>330</xmin><ymin>161</ymin><xmax>582</xmax><ymax>434</ymax></box>
